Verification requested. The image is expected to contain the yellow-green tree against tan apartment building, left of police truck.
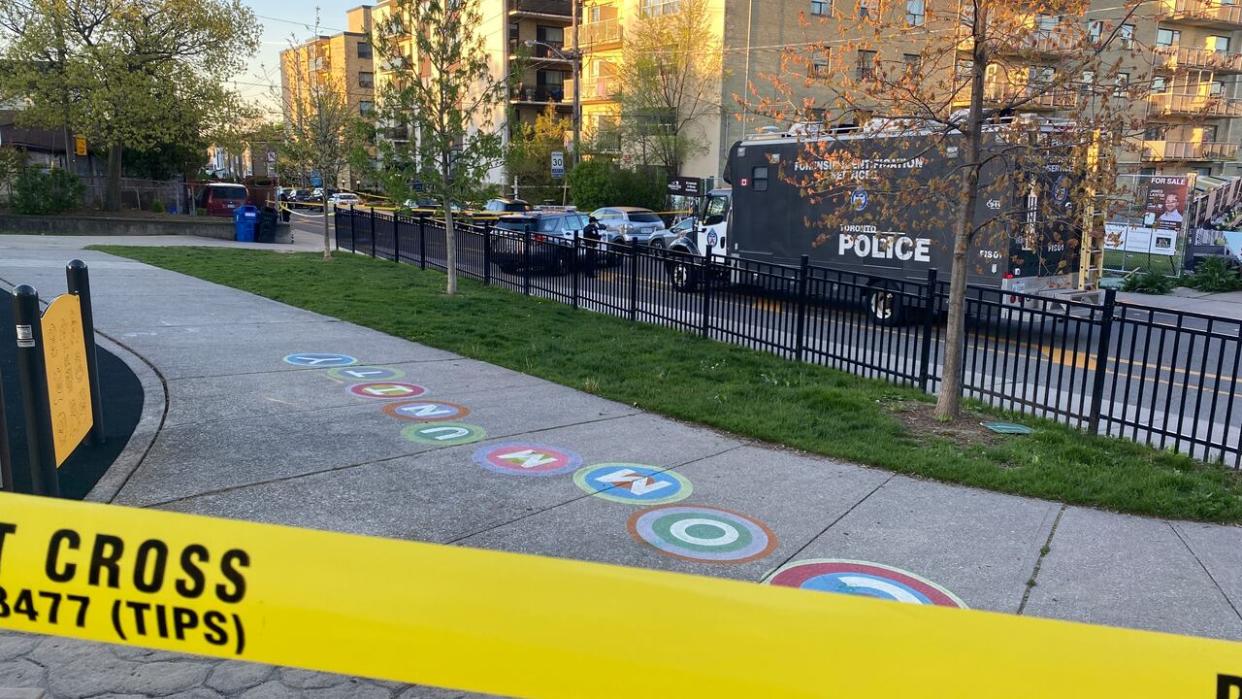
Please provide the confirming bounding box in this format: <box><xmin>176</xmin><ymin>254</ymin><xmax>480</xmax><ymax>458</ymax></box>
<box><xmin>619</xmin><ymin>0</ymin><xmax>722</xmax><ymax>176</ymax></box>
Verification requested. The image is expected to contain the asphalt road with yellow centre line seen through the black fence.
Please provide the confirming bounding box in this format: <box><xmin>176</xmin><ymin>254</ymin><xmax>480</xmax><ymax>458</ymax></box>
<box><xmin>332</xmin><ymin>213</ymin><xmax>1242</xmax><ymax>466</ymax></box>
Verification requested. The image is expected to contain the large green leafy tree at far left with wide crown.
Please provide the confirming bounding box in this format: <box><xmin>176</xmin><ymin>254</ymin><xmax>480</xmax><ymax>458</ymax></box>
<box><xmin>0</xmin><ymin>0</ymin><xmax>261</xmax><ymax>210</ymax></box>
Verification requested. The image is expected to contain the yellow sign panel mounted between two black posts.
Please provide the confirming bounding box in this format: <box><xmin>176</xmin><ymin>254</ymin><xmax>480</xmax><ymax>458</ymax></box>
<box><xmin>42</xmin><ymin>294</ymin><xmax>93</xmax><ymax>467</ymax></box>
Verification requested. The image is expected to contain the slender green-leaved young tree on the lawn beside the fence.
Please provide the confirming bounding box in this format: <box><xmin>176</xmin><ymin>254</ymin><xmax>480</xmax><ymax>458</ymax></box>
<box><xmin>375</xmin><ymin>0</ymin><xmax>509</xmax><ymax>294</ymax></box>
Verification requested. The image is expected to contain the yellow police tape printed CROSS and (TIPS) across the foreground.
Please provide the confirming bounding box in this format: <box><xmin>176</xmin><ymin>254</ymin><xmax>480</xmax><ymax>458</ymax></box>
<box><xmin>0</xmin><ymin>494</ymin><xmax>1242</xmax><ymax>699</ymax></box>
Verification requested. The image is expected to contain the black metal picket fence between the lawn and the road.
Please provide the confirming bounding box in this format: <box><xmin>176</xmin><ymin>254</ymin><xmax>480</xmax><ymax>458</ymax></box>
<box><xmin>335</xmin><ymin>210</ymin><xmax>1242</xmax><ymax>468</ymax></box>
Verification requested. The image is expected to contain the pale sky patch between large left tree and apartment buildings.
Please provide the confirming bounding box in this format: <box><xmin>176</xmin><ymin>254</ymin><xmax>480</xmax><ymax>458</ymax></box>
<box><xmin>233</xmin><ymin>0</ymin><xmax>368</xmax><ymax>117</ymax></box>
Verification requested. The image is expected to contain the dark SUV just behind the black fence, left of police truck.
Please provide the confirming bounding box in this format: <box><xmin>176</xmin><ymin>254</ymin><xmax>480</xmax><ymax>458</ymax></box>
<box><xmin>492</xmin><ymin>211</ymin><xmax>587</xmax><ymax>274</ymax></box>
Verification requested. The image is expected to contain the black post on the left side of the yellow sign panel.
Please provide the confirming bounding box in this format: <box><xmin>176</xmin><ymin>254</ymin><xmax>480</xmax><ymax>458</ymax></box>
<box><xmin>12</xmin><ymin>284</ymin><xmax>61</xmax><ymax>498</ymax></box>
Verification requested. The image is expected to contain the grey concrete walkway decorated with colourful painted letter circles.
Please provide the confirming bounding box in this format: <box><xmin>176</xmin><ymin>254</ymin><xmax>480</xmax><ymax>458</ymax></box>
<box><xmin>0</xmin><ymin>236</ymin><xmax>1242</xmax><ymax>697</ymax></box>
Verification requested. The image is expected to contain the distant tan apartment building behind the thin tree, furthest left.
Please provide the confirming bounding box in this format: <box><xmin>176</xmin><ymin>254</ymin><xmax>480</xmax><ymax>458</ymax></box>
<box><xmin>281</xmin><ymin>5</ymin><xmax>375</xmax><ymax>189</ymax></box>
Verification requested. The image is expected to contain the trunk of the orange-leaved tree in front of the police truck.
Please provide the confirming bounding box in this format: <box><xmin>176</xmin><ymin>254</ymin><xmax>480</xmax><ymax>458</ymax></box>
<box><xmin>935</xmin><ymin>2</ymin><xmax>987</xmax><ymax>420</ymax></box>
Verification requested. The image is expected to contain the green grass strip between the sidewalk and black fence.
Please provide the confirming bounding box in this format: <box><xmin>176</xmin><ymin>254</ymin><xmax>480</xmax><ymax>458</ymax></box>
<box><xmin>98</xmin><ymin>246</ymin><xmax>1242</xmax><ymax>521</ymax></box>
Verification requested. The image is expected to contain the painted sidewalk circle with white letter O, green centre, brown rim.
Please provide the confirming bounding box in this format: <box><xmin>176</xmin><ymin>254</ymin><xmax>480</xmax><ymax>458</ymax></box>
<box><xmin>630</xmin><ymin>505</ymin><xmax>776</xmax><ymax>564</ymax></box>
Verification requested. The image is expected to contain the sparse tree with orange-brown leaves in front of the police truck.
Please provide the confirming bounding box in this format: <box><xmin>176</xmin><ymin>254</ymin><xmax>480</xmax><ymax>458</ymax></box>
<box><xmin>748</xmin><ymin>0</ymin><xmax>1146</xmax><ymax>420</ymax></box>
